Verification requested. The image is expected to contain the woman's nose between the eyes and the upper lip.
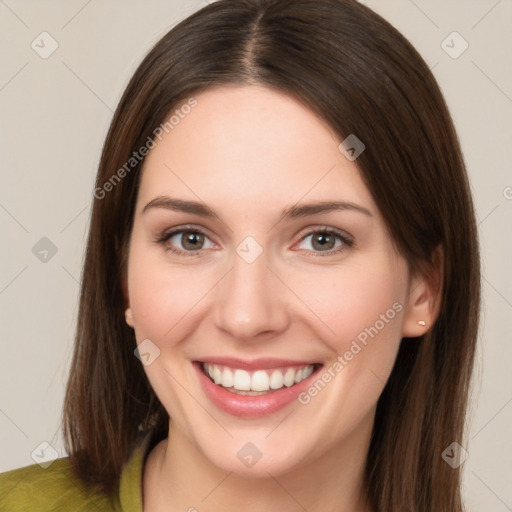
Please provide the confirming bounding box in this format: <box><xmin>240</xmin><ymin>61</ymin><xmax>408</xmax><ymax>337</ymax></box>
<box><xmin>215</xmin><ymin>247</ymin><xmax>289</xmax><ymax>342</ymax></box>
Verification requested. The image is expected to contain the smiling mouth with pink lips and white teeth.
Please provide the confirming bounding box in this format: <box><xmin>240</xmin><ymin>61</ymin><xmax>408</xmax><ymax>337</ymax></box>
<box><xmin>193</xmin><ymin>358</ymin><xmax>323</xmax><ymax>417</ymax></box>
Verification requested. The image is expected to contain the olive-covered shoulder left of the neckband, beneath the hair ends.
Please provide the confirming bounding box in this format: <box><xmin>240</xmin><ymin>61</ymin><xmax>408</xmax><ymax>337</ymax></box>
<box><xmin>0</xmin><ymin>457</ymin><xmax>118</xmax><ymax>512</ymax></box>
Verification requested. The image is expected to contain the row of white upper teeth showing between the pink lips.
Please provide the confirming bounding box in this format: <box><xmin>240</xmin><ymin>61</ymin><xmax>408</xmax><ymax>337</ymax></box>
<box><xmin>203</xmin><ymin>363</ymin><xmax>314</xmax><ymax>392</ymax></box>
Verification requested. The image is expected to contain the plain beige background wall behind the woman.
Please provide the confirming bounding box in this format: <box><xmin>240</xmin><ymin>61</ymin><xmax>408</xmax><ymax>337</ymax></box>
<box><xmin>0</xmin><ymin>0</ymin><xmax>512</xmax><ymax>512</ymax></box>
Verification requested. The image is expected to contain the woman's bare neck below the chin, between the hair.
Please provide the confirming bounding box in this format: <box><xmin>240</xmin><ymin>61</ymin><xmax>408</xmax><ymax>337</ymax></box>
<box><xmin>143</xmin><ymin>416</ymin><xmax>373</xmax><ymax>512</ymax></box>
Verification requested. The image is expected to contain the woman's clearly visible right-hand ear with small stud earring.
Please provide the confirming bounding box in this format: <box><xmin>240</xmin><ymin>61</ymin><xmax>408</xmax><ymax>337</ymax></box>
<box><xmin>402</xmin><ymin>245</ymin><xmax>444</xmax><ymax>338</ymax></box>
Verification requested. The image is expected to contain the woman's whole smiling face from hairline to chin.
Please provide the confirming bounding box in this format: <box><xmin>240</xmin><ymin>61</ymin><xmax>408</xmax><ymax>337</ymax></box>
<box><xmin>127</xmin><ymin>86</ymin><xmax>418</xmax><ymax>476</ymax></box>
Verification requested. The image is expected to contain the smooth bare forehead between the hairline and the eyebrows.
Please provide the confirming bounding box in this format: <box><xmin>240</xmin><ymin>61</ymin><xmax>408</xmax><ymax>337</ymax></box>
<box><xmin>139</xmin><ymin>86</ymin><xmax>375</xmax><ymax>216</ymax></box>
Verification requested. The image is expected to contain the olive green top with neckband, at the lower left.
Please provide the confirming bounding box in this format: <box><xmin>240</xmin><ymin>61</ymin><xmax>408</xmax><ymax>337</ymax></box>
<box><xmin>0</xmin><ymin>432</ymin><xmax>155</xmax><ymax>512</ymax></box>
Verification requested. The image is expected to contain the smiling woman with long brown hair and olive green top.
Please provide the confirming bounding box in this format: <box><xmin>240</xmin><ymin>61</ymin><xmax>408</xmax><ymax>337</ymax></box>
<box><xmin>0</xmin><ymin>0</ymin><xmax>480</xmax><ymax>512</ymax></box>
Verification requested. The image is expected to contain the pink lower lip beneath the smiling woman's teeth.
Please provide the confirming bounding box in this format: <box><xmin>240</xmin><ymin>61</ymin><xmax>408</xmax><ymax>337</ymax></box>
<box><xmin>193</xmin><ymin>362</ymin><xmax>321</xmax><ymax>418</ymax></box>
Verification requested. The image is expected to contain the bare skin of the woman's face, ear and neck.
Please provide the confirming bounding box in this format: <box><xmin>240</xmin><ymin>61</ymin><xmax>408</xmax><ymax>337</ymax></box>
<box><xmin>125</xmin><ymin>86</ymin><xmax>436</xmax><ymax>512</ymax></box>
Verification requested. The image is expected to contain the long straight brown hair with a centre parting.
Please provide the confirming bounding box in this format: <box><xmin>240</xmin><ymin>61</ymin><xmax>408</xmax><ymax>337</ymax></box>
<box><xmin>63</xmin><ymin>0</ymin><xmax>480</xmax><ymax>512</ymax></box>
